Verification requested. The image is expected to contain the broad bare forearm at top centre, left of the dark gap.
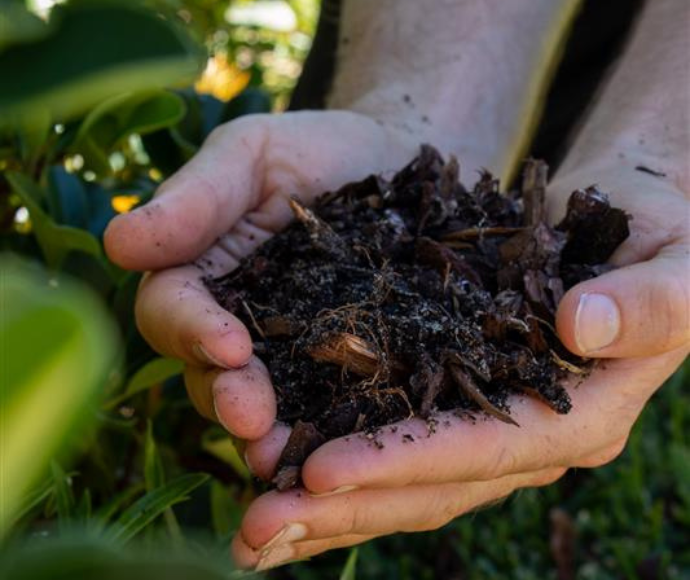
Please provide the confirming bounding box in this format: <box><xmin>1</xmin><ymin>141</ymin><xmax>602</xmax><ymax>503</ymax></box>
<box><xmin>328</xmin><ymin>0</ymin><xmax>579</xmax><ymax>177</ymax></box>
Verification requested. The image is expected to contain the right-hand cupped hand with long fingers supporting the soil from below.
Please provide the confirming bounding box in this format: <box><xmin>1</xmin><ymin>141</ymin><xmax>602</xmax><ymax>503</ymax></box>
<box><xmin>233</xmin><ymin>160</ymin><xmax>690</xmax><ymax>569</ymax></box>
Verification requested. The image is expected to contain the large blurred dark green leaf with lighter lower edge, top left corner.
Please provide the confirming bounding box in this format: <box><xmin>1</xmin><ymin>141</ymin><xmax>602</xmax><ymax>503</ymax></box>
<box><xmin>0</xmin><ymin>2</ymin><xmax>202</xmax><ymax>124</ymax></box>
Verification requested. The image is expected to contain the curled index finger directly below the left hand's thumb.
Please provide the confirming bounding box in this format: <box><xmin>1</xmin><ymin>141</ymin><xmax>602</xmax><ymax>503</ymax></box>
<box><xmin>135</xmin><ymin>266</ymin><xmax>252</xmax><ymax>368</ymax></box>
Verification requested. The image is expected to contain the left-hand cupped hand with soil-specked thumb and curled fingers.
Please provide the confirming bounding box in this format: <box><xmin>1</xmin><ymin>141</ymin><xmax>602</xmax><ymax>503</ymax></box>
<box><xmin>105</xmin><ymin>111</ymin><xmax>418</xmax><ymax>440</ymax></box>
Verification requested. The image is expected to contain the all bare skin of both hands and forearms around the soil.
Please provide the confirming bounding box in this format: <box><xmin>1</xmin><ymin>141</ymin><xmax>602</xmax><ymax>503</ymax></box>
<box><xmin>105</xmin><ymin>0</ymin><xmax>690</xmax><ymax>569</ymax></box>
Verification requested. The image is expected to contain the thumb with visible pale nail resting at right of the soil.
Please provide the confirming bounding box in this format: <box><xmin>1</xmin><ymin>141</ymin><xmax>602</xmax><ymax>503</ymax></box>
<box><xmin>556</xmin><ymin>245</ymin><xmax>690</xmax><ymax>358</ymax></box>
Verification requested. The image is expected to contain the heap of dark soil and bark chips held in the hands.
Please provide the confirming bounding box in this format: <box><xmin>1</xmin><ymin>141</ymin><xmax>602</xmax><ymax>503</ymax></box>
<box><xmin>207</xmin><ymin>146</ymin><xmax>628</xmax><ymax>488</ymax></box>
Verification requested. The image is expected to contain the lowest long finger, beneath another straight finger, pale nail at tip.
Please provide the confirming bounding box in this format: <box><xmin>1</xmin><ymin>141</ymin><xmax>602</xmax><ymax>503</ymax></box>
<box><xmin>241</xmin><ymin>469</ymin><xmax>565</xmax><ymax>560</ymax></box>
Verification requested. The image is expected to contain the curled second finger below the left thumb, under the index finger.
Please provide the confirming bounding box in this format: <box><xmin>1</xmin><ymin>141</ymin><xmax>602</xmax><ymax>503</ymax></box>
<box><xmin>185</xmin><ymin>356</ymin><xmax>276</xmax><ymax>440</ymax></box>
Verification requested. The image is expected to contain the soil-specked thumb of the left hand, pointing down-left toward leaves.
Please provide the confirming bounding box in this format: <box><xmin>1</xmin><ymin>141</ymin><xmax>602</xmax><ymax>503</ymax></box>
<box><xmin>103</xmin><ymin>116</ymin><xmax>265</xmax><ymax>270</ymax></box>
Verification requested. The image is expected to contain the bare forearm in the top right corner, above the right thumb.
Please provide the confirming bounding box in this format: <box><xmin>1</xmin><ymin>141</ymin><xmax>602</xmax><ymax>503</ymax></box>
<box><xmin>559</xmin><ymin>0</ymin><xmax>690</xmax><ymax>195</ymax></box>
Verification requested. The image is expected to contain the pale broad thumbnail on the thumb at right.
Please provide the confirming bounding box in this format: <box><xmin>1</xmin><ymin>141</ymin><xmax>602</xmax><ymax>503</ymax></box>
<box><xmin>575</xmin><ymin>294</ymin><xmax>621</xmax><ymax>353</ymax></box>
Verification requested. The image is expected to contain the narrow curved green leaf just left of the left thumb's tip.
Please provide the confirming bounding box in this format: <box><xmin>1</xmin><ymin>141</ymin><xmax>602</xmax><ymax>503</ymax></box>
<box><xmin>6</xmin><ymin>172</ymin><xmax>102</xmax><ymax>269</ymax></box>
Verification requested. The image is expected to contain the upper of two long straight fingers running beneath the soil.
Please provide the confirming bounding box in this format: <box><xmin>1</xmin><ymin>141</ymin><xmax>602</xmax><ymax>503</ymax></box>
<box><xmin>302</xmin><ymin>349</ymin><xmax>687</xmax><ymax>493</ymax></box>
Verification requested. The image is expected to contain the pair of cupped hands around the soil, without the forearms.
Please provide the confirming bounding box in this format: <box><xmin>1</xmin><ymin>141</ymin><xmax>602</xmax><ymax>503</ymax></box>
<box><xmin>105</xmin><ymin>111</ymin><xmax>690</xmax><ymax>569</ymax></box>
